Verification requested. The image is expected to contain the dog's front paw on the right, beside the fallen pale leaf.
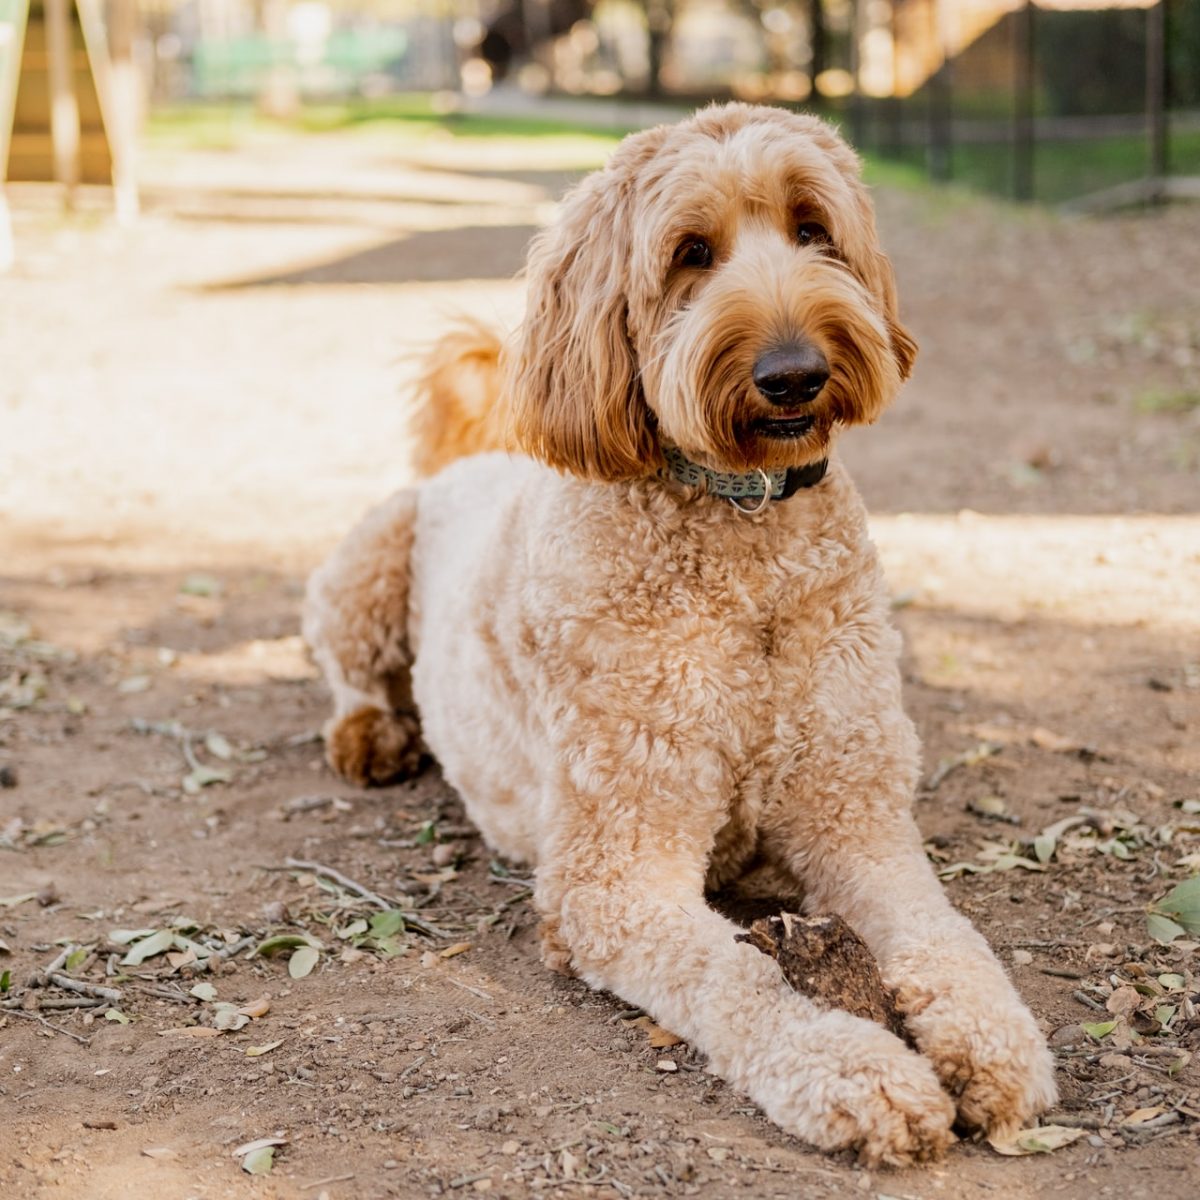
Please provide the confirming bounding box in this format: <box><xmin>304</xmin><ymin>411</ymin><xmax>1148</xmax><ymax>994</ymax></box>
<box><xmin>901</xmin><ymin>966</ymin><xmax>1057</xmax><ymax>1134</ymax></box>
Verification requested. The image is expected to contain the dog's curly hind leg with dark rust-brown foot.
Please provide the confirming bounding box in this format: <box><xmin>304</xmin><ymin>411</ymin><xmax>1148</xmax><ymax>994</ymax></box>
<box><xmin>304</xmin><ymin>490</ymin><xmax>425</xmax><ymax>787</ymax></box>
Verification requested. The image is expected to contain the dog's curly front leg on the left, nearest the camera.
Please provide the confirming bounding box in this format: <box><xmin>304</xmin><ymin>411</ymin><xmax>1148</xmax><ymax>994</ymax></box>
<box><xmin>538</xmin><ymin>798</ymin><xmax>954</xmax><ymax>1164</ymax></box>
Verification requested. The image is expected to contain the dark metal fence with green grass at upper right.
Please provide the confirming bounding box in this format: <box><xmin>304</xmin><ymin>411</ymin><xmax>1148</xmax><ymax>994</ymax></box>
<box><xmin>839</xmin><ymin>0</ymin><xmax>1200</xmax><ymax>208</ymax></box>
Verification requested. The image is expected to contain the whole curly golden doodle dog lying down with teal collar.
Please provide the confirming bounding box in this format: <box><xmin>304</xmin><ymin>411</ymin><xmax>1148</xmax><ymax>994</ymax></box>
<box><xmin>305</xmin><ymin>104</ymin><xmax>1055</xmax><ymax>1164</ymax></box>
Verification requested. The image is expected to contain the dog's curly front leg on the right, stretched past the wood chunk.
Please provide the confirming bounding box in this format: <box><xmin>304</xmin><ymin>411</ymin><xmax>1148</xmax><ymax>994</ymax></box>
<box><xmin>767</xmin><ymin>667</ymin><xmax>1055</xmax><ymax>1133</ymax></box>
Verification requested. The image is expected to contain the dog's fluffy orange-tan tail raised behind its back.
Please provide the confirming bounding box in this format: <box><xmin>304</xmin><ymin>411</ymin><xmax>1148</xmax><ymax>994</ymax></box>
<box><xmin>412</xmin><ymin>322</ymin><xmax>508</xmax><ymax>478</ymax></box>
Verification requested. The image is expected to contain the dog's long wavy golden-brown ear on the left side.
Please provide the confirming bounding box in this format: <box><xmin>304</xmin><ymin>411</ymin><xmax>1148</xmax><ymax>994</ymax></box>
<box><xmin>509</xmin><ymin>131</ymin><xmax>661</xmax><ymax>480</ymax></box>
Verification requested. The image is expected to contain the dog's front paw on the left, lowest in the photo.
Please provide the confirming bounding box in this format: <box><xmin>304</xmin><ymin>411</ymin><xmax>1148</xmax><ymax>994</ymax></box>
<box><xmin>764</xmin><ymin>1013</ymin><xmax>954</xmax><ymax>1166</ymax></box>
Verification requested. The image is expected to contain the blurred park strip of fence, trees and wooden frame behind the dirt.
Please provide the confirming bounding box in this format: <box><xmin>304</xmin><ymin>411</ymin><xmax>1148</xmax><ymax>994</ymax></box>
<box><xmin>0</xmin><ymin>0</ymin><xmax>1200</xmax><ymax>219</ymax></box>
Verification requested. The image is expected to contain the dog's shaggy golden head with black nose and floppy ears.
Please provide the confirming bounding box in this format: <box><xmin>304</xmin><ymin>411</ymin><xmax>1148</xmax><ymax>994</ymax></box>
<box><xmin>510</xmin><ymin>104</ymin><xmax>916</xmax><ymax>479</ymax></box>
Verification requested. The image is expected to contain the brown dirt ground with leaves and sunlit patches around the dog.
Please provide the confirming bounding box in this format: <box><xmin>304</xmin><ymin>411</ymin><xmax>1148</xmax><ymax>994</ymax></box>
<box><xmin>0</xmin><ymin>119</ymin><xmax>1200</xmax><ymax>1200</ymax></box>
